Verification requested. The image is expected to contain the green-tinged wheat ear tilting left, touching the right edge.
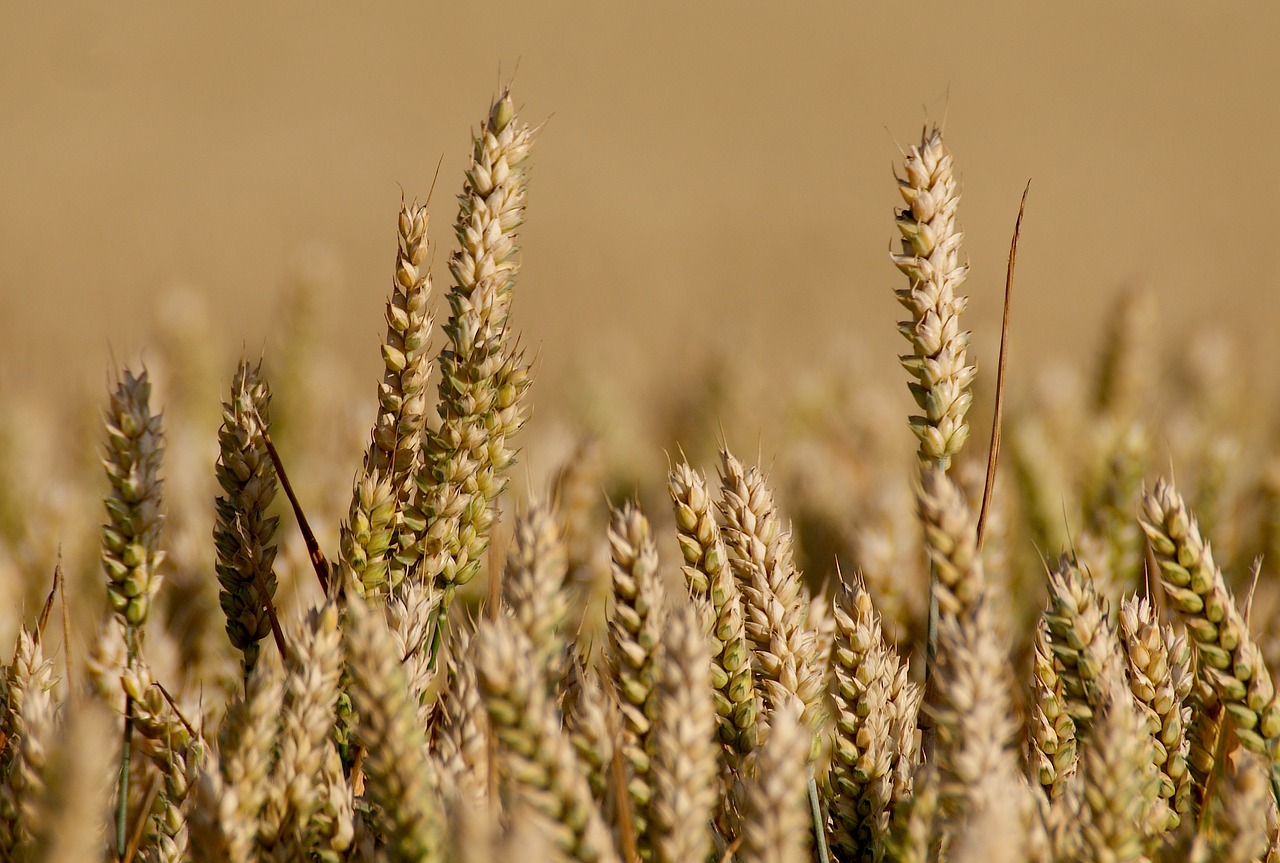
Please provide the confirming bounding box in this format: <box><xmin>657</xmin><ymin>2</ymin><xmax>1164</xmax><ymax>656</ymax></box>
<box><xmin>1140</xmin><ymin>480</ymin><xmax>1280</xmax><ymax>757</ymax></box>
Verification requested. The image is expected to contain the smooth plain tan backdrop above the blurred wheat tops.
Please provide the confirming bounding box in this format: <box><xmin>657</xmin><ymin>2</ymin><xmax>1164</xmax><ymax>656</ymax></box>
<box><xmin>0</xmin><ymin>3</ymin><xmax>1280</xmax><ymax>411</ymax></box>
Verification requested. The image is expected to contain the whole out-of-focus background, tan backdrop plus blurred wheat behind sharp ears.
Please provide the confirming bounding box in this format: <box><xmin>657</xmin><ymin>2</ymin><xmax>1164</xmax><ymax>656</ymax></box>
<box><xmin>0</xmin><ymin>0</ymin><xmax>1280</xmax><ymax>662</ymax></box>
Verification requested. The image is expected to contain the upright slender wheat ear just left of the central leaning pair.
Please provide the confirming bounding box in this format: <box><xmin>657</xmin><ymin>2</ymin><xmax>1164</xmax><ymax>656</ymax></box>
<box><xmin>609</xmin><ymin>503</ymin><xmax>663</xmax><ymax>854</ymax></box>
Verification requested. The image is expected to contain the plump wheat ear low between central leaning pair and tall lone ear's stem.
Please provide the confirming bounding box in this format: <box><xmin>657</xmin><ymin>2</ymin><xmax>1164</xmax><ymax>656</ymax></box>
<box><xmin>827</xmin><ymin>573</ymin><xmax>914</xmax><ymax>860</ymax></box>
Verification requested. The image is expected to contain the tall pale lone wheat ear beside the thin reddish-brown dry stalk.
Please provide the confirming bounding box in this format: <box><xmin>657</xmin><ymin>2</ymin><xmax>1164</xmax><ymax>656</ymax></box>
<box><xmin>892</xmin><ymin>127</ymin><xmax>975</xmax><ymax>470</ymax></box>
